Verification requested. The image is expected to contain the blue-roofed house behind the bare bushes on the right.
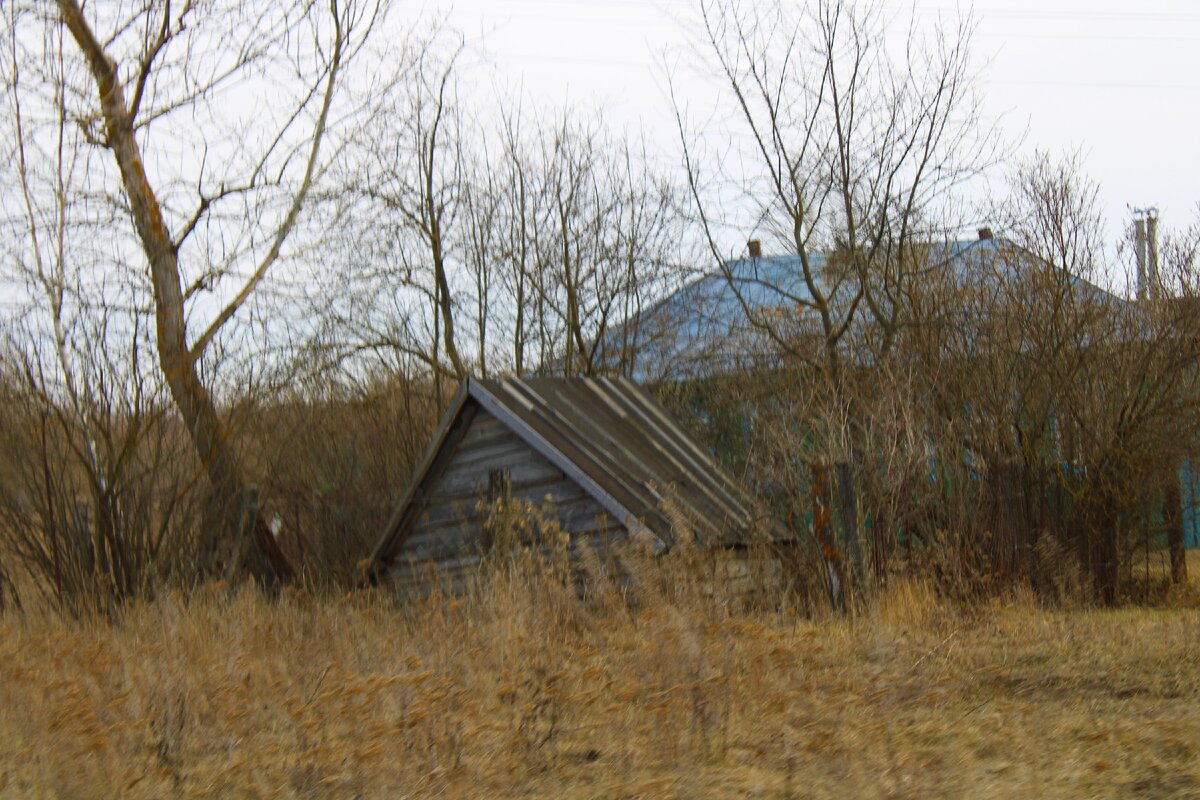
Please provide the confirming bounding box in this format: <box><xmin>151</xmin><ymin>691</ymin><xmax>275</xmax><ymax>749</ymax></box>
<box><xmin>588</xmin><ymin>235</ymin><xmax>1200</xmax><ymax>604</ymax></box>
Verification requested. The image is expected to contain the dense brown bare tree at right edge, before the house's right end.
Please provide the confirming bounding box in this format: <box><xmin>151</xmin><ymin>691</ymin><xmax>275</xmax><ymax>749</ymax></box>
<box><xmin>896</xmin><ymin>156</ymin><xmax>1200</xmax><ymax>603</ymax></box>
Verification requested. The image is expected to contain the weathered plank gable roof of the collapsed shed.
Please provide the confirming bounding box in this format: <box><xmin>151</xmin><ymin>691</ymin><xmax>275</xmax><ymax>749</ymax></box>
<box><xmin>371</xmin><ymin>378</ymin><xmax>763</xmax><ymax>573</ymax></box>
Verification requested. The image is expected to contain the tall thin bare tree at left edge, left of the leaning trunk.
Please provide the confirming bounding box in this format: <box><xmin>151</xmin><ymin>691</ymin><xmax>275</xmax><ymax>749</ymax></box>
<box><xmin>0</xmin><ymin>3</ymin><xmax>204</xmax><ymax>612</ymax></box>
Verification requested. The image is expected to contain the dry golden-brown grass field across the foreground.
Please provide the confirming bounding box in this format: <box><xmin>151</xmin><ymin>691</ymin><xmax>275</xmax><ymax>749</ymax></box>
<box><xmin>0</xmin><ymin>563</ymin><xmax>1200</xmax><ymax>798</ymax></box>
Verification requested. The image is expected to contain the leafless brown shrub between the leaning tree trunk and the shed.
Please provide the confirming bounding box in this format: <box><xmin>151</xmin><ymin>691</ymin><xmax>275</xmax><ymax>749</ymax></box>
<box><xmin>230</xmin><ymin>371</ymin><xmax>445</xmax><ymax>587</ymax></box>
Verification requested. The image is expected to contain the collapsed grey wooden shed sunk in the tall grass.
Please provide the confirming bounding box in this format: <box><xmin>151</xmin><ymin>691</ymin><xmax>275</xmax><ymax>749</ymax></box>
<box><xmin>371</xmin><ymin>378</ymin><xmax>782</xmax><ymax>589</ymax></box>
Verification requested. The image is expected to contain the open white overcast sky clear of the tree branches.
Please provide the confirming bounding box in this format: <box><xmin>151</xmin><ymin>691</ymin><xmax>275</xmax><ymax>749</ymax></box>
<box><xmin>426</xmin><ymin>0</ymin><xmax>1200</xmax><ymax>244</ymax></box>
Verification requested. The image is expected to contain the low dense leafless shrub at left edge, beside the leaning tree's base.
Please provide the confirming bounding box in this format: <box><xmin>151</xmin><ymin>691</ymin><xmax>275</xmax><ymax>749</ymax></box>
<box><xmin>0</xmin><ymin>319</ymin><xmax>205</xmax><ymax>613</ymax></box>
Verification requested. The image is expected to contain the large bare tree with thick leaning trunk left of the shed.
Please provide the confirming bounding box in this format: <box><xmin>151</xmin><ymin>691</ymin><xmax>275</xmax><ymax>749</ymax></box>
<box><xmin>41</xmin><ymin>0</ymin><xmax>382</xmax><ymax>582</ymax></box>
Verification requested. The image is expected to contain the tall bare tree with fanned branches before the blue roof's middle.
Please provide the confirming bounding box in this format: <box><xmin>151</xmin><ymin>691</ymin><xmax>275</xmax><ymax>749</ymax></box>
<box><xmin>676</xmin><ymin>0</ymin><xmax>997</xmax><ymax>606</ymax></box>
